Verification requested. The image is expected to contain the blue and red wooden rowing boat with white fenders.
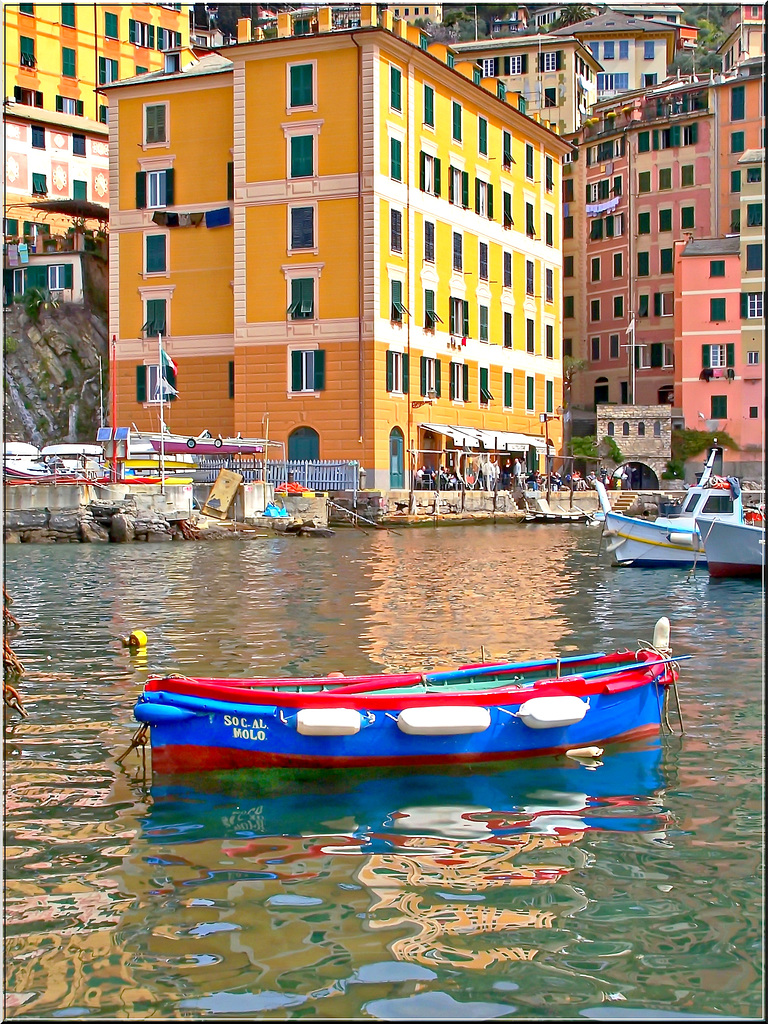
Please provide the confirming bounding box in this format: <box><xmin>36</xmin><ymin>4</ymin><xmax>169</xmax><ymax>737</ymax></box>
<box><xmin>134</xmin><ymin>618</ymin><xmax>677</xmax><ymax>774</ymax></box>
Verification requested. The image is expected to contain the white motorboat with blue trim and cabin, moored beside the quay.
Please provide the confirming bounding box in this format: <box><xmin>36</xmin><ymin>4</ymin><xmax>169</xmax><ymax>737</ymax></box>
<box><xmin>595</xmin><ymin>447</ymin><xmax>744</xmax><ymax>566</ymax></box>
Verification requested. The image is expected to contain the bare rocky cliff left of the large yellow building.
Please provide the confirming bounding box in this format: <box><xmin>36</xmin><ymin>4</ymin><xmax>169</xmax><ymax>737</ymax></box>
<box><xmin>3</xmin><ymin>302</ymin><xmax>110</xmax><ymax>446</ymax></box>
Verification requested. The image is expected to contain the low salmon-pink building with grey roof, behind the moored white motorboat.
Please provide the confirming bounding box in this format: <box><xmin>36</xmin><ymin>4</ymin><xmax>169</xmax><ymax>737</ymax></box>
<box><xmin>674</xmin><ymin>236</ymin><xmax>763</xmax><ymax>476</ymax></box>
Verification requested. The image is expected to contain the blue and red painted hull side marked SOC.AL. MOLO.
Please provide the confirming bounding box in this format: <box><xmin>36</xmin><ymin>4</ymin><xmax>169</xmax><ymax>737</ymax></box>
<box><xmin>134</xmin><ymin>666</ymin><xmax>665</xmax><ymax>774</ymax></box>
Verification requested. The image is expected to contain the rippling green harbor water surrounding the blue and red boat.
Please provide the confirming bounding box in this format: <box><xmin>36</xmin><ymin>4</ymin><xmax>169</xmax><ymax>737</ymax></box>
<box><xmin>4</xmin><ymin>523</ymin><xmax>765</xmax><ymax>1020</ymax></box>
